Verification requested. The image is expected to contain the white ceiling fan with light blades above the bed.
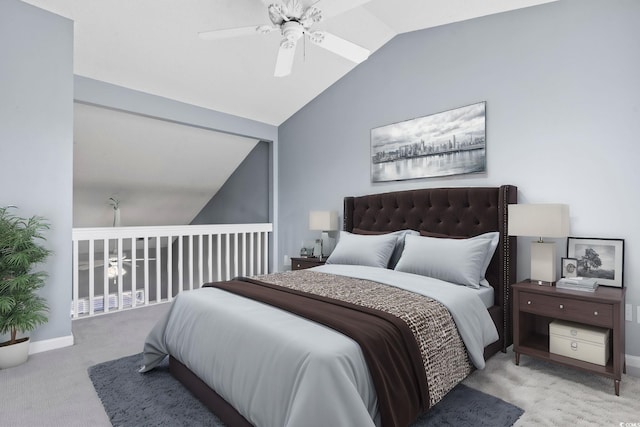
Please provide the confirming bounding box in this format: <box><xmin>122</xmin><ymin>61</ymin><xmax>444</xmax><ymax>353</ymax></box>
<box><xmin>198</xmin><ymin>0</ymin><xmax>371</xmax><ymax>77</ymax></box>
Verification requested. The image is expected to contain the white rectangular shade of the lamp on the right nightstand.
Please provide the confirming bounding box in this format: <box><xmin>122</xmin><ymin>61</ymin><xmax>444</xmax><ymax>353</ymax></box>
<box><xmin>509</xmin><ymin>203</ymin><xmax>569</xmax><ymax>237</ymax></box>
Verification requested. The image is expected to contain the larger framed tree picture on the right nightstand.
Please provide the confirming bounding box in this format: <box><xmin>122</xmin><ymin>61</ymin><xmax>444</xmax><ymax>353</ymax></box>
<box><xmin>563</xmin><ymin>237</ymin><xmax>624</xmax><ymax>288</ymax></box>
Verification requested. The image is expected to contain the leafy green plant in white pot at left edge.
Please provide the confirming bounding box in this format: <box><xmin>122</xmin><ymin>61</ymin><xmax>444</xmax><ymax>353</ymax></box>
<box><xmin>0</xmin><ymin>206</ymin><xmax>51</xmax><ymax>369</ymax></box>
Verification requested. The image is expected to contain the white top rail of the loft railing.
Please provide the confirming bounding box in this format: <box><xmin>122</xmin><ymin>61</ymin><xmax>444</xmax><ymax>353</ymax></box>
<box><xmin>71</xmin><ymin>223</ymin><xmax>273</xmax><ymax>240</ymax></box>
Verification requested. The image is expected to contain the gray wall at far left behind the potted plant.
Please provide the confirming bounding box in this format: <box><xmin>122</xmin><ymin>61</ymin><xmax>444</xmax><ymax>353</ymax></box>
<box><xmin>0</xmin><ymin>0</ymin><xmax>73</xmax><ymax>341</ymax></box>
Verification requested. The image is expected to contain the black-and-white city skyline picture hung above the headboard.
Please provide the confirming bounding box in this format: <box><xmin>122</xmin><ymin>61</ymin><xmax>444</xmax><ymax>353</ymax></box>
<box><xmin>370</xmin><ymin>102</ymin><xmax>487</xmax><ymax>182</ymax></box>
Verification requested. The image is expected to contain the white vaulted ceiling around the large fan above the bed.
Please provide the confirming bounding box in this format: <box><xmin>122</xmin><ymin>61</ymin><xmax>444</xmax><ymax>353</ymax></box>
<box><xmin>24</xmin><ymin>0</ymin><xmax>554</xmax><ymax>125</ymax></box>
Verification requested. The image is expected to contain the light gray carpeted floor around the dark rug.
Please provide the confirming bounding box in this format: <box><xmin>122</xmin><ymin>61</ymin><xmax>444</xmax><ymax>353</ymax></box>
<box><xmin>0</xmin><ymin>304</ymin><xmax>640</xmax><ymax>427</ymax></box>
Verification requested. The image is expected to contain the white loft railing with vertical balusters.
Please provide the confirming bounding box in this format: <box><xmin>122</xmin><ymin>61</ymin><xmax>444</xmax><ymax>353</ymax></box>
<box><xmin>71</xmin><ymin>224</ymin><xmax>273</xmax><ymax>318</ymax></box>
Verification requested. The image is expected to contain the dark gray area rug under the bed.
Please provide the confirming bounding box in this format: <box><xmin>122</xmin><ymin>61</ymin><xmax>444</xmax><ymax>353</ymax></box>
<box><xmin>89</xmin><ymin>354</ymin><xmax>524</xmax><ymax>427</ymax></box>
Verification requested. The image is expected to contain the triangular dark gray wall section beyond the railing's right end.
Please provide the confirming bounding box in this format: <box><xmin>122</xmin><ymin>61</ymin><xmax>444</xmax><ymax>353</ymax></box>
<box><xmin>191</xmin><ymin>141</ymin><xmax>271</xmax><ymax>224</ymax></box>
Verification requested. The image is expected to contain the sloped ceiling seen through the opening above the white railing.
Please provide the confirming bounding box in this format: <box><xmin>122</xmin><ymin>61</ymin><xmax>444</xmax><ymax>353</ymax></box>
<box><xmin>73</xmin><ymin>103</ymin><xmax>258</xmax><ymax>227</ymax></box>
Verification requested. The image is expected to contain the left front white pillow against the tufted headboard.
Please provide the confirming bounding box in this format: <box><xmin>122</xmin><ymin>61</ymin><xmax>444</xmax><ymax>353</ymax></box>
<box><xmin>327</xmin><ymin>231</ymin><xmax>397</xmax><ymax>268</ymax></box>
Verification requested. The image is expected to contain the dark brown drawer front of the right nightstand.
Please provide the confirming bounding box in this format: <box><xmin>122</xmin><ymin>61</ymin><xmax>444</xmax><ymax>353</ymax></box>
<box><xmin>519</xmin><ymin>292</ymin><xmax>613</xmax><ymax>328</ymax></box>
